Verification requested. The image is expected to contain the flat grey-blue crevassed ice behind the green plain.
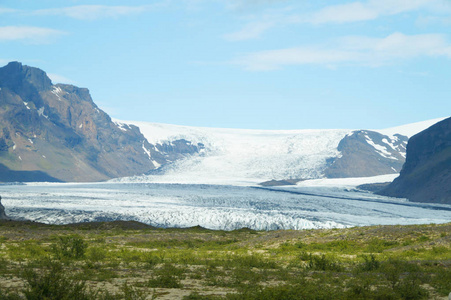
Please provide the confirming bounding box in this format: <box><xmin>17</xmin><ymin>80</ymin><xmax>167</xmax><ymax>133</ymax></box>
<box><xmin>0</xmin><ymin>182</ymin><xmax>451</xmax><ymax>230</ymax></box>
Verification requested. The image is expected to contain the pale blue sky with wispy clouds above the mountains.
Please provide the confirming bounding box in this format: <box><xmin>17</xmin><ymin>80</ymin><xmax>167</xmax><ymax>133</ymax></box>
<box><xmin>0</xmin><ymin>0</ymin><xmax>451</xmax><ymax>129</ymax></box>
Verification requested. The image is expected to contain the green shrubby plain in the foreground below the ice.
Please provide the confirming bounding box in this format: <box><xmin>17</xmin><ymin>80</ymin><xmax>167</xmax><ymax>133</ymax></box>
<box><xmin>0</xmin><ymin>221</ymin><xmax>451</xmax><ymax>299</ymax></box>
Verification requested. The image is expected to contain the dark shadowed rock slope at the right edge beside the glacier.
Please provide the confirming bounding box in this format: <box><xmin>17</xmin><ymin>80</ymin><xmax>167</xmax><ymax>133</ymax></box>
<box><xmin>380</xmin><ymin>118</ymin><xmax>451</xmax><ymax>204</ymax></box>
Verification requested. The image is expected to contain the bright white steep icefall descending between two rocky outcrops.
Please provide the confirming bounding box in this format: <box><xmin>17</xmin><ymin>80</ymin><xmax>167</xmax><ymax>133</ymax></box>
<box><xmin>121</xmin><ymin>121</ymin><xmax>351</xmax><ymax>185</ymax></box>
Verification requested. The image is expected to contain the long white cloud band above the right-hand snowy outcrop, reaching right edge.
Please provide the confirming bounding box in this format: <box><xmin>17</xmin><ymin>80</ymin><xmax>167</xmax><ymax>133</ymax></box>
<box><xmin>231</xmin><ymin>33</ymin><xmax>451</xmax><ymax>71</ymax></box>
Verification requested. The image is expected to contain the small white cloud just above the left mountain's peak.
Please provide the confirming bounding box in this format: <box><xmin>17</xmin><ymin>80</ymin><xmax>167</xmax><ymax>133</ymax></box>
<box><xmin>0</xmin><ymin>26</ymin><xmax>66</xmax><ymax>43</ymax></box>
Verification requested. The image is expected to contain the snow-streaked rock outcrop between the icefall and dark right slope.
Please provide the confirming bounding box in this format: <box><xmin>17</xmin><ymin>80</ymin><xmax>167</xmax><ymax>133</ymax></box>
<box><xmin>325</xmin><ymin>130</ymin><xmax>408</xmax><ymax>178</ymax></box>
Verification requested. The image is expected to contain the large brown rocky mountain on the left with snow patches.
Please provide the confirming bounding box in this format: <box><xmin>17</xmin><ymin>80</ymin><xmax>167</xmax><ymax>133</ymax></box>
<box><xmin>0</xmin><ymin>62</ymin><xmax>201</xmax><ymax>182</ymax></box>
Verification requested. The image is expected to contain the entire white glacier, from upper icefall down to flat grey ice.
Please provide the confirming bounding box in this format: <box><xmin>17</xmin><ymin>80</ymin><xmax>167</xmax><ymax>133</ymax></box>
<box><xmin>0</xmin><ymin>120</ymin><xmax>451</xmax><ymax>230</ymax></box>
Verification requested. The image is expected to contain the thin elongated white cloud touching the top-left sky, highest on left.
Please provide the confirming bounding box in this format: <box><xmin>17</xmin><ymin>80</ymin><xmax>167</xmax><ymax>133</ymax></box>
<box><xmin>32</xmin><ymin>4</ymin><xmax>162</xmax><ymax>20</ymax></box>
